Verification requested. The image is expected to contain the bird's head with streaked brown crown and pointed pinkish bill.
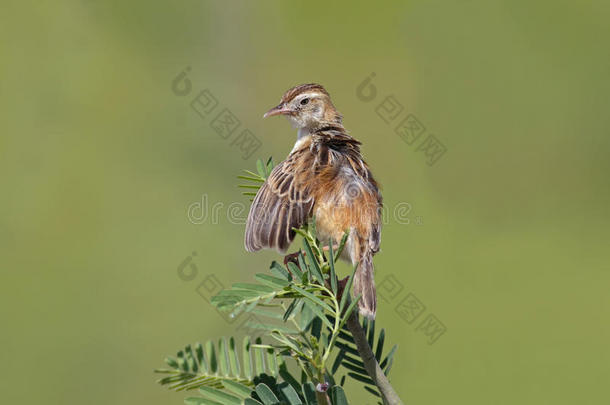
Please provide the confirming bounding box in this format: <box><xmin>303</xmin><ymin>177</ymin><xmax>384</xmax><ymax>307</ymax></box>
<box><xmin>263</xmin><ymin>83</ymin><xmax>341</xmax><ymax>131</ymax></box>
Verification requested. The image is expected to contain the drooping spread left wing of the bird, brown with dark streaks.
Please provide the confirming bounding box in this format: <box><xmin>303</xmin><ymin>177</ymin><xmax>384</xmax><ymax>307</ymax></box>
<box><xmin>245</xmin><ymin>151</ymin><xmax>314</xmax><ymax>253</ymax></box>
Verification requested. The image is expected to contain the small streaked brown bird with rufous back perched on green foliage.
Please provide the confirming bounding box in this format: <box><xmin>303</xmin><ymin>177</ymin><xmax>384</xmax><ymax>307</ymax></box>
<box><xmin>245</xmin><ymin>83</ymin><xmax>383</xmax><ymax>320</ymax></box>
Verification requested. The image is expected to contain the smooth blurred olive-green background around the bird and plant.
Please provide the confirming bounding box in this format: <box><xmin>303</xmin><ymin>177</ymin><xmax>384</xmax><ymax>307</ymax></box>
<box><xmin>0</xmin><ymin>0</ymin><xmax>610</xmax><ymax>404</ymax></box>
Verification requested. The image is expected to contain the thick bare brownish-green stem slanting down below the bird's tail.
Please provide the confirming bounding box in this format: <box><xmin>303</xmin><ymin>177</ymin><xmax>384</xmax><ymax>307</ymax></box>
<box><xmin>346</xmin><ymin>311</ymin><xmax>403</xmax><ymax>405</ymax></box>
